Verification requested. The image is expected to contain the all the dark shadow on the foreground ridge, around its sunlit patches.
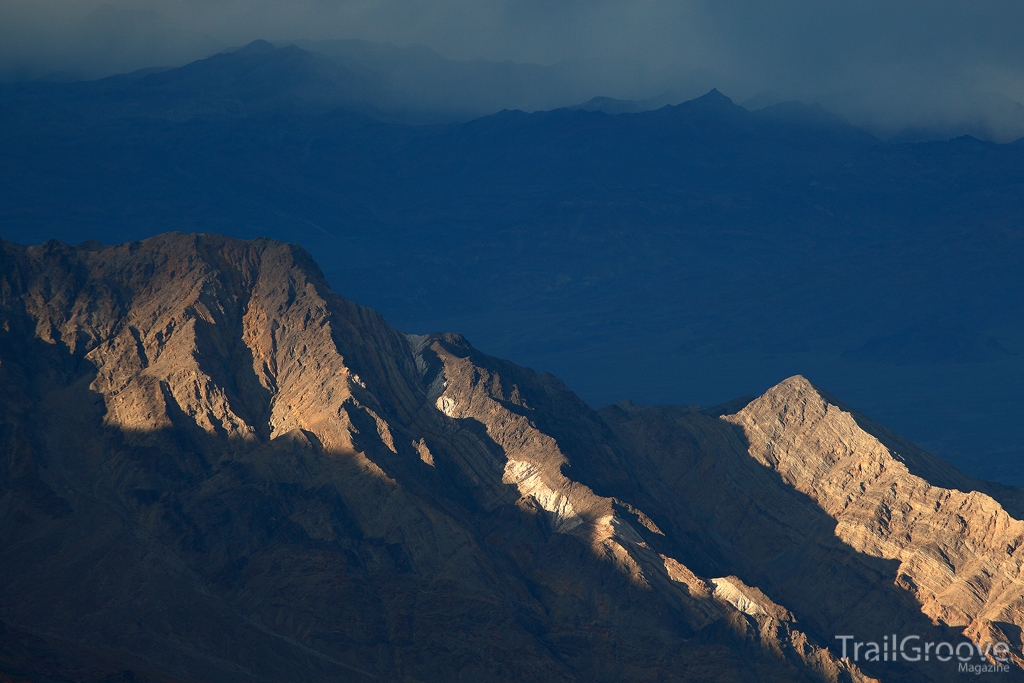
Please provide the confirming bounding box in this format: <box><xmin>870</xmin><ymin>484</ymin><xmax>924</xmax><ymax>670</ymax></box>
<box><xmin>0</xmin><ymin>235</ymin><xmax>1016</xmax><ymax>683</ymax></box>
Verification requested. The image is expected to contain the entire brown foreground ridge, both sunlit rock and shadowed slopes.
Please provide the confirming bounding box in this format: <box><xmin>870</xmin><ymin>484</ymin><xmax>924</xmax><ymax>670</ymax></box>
<box><xmin>0</xmin><ymin>233</ymin><xmax>1024</xmax><ymax>683</ymax></box>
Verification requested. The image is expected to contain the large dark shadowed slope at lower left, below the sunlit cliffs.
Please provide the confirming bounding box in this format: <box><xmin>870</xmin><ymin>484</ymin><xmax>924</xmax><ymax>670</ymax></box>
<box><xmin>0</xmin><ymin>323</ymin><xmax>831</xmax><ymax>682</ymax></box>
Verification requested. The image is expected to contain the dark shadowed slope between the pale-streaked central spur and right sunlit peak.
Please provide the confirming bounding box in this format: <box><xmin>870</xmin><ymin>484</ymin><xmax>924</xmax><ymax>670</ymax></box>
<box><xmin>393</xmin><ymin>333</ymin><xmax>1024</xmax><ymax>680</ymax></box>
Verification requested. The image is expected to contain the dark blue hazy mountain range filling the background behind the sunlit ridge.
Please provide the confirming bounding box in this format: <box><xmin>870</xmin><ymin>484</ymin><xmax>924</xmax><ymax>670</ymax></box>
<box><xmin>0</xmin><ymin>43</ymin><xmax>1024</xmax><ymax>483</ymax></box>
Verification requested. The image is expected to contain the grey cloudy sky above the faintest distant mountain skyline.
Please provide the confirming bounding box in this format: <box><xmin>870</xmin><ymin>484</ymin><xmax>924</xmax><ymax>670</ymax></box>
<box><xmin>6</xmin><ymin>0</ymin><xmax>1024</xmax><ymax>137</ymax></box>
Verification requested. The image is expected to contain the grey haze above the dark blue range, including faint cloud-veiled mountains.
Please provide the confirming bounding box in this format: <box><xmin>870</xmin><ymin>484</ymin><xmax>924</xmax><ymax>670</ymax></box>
<box><xmin>6</xmin><ymin>0</ymin><xmax>1024</xmax><ymax>141</ymax></box>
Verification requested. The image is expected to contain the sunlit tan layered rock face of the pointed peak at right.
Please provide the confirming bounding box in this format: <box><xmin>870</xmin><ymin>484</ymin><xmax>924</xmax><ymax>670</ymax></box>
<box><xmin>722</xmin><ymin>376</ymin><xmax>1024</xmax><ymax>667</ymax></box>
